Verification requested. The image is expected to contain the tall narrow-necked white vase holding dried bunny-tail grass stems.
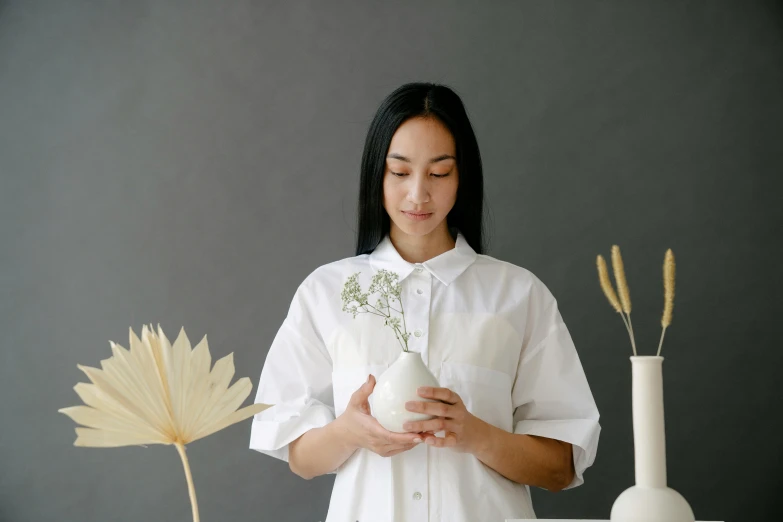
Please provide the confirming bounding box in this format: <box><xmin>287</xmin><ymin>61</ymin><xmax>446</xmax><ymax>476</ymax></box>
<box><xmin>611</xmin><ymin>356</ymin><xmax>694</xmax><ymax>522</ymax></box>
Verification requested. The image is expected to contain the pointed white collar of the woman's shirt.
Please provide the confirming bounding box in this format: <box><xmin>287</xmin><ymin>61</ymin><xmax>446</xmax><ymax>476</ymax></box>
<box><xmin>370</xmin><ymin>232</ymin><xmax>477</xmax><ymax>286</ymax></box>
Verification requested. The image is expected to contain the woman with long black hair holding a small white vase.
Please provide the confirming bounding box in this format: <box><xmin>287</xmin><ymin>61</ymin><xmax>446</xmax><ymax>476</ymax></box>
<box><xmin>250</xmin><ymin>83</ymin><xmax>600</xmax><ymax>522</ymax></box>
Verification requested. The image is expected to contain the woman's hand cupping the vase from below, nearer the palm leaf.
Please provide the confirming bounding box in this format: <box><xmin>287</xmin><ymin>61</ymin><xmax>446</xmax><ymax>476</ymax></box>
<box><xmin>334</xmin><ymin>375</ymin><xmax>423</xmax><ymax>457</ymax></box>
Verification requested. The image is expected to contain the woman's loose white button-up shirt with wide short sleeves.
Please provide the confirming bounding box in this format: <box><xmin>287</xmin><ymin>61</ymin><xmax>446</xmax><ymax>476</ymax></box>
<box><xmin>250</xmin><ymin>234</ymin><xmax>600</xmax><ymax>522</ymax></box>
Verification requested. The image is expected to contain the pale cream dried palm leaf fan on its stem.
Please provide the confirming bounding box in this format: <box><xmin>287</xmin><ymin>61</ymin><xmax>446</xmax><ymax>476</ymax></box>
<box><xmin>59</xmin><ymin>325</ymin><xmax>270</xmax><ymax>522</ymax></box>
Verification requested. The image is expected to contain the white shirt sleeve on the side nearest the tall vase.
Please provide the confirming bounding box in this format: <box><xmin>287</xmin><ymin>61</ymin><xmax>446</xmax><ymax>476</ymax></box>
<box><xmin>511</xmin><ymin>281</ymin><xmax>601</xmax><ymax>489</ymax></box>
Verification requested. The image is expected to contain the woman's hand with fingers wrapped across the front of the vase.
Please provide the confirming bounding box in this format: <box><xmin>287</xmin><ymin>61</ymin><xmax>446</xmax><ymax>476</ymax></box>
<box><xmin>403</xmin><ymin>386</ymin><xmax>487</xmax><ymax>453</ymax></box>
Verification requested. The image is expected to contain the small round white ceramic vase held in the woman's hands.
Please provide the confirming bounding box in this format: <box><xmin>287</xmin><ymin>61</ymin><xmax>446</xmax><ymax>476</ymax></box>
<box><xmin>370</xmin><ymin>351</ymin><xmax>440</xmax><ymax>433</ymax></box>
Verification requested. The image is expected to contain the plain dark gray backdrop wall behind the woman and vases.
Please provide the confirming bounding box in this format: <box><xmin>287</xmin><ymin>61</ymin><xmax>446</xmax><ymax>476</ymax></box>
<box><xmin>0</xmin><ymin>0</ymin><xmax>783</xmax><ymax>522</ymax></box>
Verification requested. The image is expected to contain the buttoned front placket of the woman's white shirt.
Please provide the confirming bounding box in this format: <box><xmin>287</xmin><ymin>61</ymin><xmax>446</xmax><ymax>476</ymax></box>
<box><xmin>395</xmin><ymin>264</ymin><xmax>432</xmax><ymax>521</ymax></box>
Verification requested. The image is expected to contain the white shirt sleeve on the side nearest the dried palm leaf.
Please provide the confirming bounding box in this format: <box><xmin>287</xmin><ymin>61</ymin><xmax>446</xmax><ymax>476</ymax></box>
<box><xmin>250</xmin><ymin>283</ymin><xmax>335</xmax><ymax>462</ymax></box>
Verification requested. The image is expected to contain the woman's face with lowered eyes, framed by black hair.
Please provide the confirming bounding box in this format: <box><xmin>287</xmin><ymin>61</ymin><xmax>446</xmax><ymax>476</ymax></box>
<box><xmin>383</xmin><ymin>117</ymin><xmax>459</xmax><ymax>236</ymax></box>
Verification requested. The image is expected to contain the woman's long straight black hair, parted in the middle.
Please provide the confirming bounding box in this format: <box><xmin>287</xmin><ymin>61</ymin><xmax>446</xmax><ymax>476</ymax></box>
<box><xmin>356</xmin><ymin>83</ymin><xmax>484</xmax><ymax>256</ymax></box>
